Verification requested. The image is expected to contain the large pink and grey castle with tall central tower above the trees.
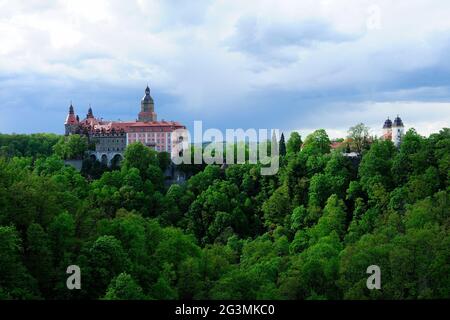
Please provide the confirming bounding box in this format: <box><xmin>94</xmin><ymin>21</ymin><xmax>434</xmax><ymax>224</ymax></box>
<box><xmin>64</xmin><ymin>86</ymin><xmax>186</xmax><ymax>165</ymax></box>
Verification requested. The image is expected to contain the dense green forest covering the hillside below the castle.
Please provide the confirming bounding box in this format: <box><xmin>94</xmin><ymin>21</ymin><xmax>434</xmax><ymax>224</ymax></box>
<box><xmin>0</xmin><ymin>125</ymin><xmax>450</xmax><ymax>299</ymax></box>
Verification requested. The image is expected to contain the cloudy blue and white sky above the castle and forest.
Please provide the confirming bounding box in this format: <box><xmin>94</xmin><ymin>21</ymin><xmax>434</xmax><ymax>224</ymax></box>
<box><xmin>0</xmin><ymin>0</ymin><xmax>450</xmax><ymax>137</ymax></box>
